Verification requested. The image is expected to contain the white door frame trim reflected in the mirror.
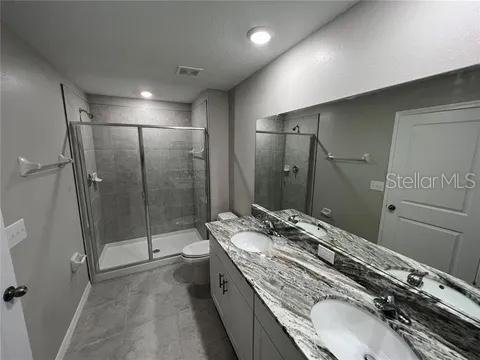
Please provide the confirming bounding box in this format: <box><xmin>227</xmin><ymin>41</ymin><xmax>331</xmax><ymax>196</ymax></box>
<box><xmin>377</xmin><ymin>100</ymin><xmax>480</xmax><ymax>245</ymax></box>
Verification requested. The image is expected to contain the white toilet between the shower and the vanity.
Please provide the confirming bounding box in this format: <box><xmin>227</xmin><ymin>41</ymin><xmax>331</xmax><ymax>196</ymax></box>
<box><xmin>182</xmin><ymin>212</ymin><xmax>237</xmax><ymax>285</ymax></box>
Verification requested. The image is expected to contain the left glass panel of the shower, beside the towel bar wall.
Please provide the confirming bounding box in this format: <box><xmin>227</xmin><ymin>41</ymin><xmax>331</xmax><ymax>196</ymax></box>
<box><xmin>71</xmin><ymin>123</ymin><xmax>150</xmax><ymax>272</ymax></box>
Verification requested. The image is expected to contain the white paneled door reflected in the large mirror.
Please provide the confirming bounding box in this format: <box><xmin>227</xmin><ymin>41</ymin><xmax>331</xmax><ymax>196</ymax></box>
<box><xmin>379</xmin><ymin>102</ymin><xmax>480</xmax><ymax>283</ymax></box>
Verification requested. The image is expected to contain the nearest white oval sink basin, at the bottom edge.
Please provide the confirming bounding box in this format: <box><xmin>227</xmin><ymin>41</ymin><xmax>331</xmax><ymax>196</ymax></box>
<box><xmin>310</xmin><ymin>300</ymin><xmax>418</xmax><ymax>360</ymax></box>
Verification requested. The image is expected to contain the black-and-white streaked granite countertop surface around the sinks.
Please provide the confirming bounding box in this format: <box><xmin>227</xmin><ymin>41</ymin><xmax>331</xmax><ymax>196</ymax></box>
<box><xmin>207</xmin><ymin>216</ymin><xmax>470</xmax><ymax>360</ymax></box>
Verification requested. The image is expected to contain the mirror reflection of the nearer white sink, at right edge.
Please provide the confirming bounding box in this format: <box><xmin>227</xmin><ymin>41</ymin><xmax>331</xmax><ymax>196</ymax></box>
<box><xmin>387</xmin><ymin>269</ymin><xmax>480</xmax><ymax>319</ymax></box>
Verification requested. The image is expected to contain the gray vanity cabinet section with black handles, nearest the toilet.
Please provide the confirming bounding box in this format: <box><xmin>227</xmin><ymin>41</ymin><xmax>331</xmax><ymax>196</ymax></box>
<box><xmin>210</xmin><ymin>240</ymin><xmax>253</xmax><ymax>360</ymax></box>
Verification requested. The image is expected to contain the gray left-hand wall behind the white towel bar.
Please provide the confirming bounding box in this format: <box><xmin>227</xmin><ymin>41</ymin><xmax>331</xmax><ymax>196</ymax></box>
<box><xmin>1</xmin><ymin>26</ymin><xmax>88</xmax><ymax>360</ymax></box>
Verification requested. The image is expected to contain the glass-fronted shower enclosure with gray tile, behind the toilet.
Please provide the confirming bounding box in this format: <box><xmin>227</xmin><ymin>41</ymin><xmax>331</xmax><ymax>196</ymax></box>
<box><xmin>69</xmin><ymin>122</ymin><xmax>210</xmax><ymax>281</ymax></box>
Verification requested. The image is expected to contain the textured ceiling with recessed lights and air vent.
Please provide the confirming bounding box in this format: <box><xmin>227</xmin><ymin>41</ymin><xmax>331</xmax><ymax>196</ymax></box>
<box><xmin>1</xmin><ymin>1</ymin><xmax>354</xmax><ymax>102</ymax></box>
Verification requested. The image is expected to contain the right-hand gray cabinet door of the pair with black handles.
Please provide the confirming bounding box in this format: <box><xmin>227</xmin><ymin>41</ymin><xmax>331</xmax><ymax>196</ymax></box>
<box><xmin>223</xmin><ymin>274</ymin><xmax>253</xmax><ymax>360</ymax></box>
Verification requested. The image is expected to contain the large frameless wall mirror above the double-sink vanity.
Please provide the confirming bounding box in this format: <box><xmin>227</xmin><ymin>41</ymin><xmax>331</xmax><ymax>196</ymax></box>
<box><xmin>255</xmin><ymin>67</ymin><xmax>480</xmax><ymax>321</ymax></box>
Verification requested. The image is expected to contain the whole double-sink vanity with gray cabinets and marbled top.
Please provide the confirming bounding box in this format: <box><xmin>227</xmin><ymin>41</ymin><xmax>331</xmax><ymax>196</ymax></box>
<box><xmin>207</xmin><ymin>213</ymin><xmax>480</xmax><ymax>360</ymax></box>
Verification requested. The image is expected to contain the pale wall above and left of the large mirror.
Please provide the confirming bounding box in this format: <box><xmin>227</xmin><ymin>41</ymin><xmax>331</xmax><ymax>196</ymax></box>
<box><xmin>230</xmin><ymin>1</ymin><xmax>480</xmax><ymax>214</ymax></box>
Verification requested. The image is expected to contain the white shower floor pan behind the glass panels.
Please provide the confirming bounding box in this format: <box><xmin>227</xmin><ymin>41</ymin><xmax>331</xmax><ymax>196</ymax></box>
<box><xmin>99</xmin><ymin>228</ymin><xmax>203</xmax><ymax>270</ymax></box>
